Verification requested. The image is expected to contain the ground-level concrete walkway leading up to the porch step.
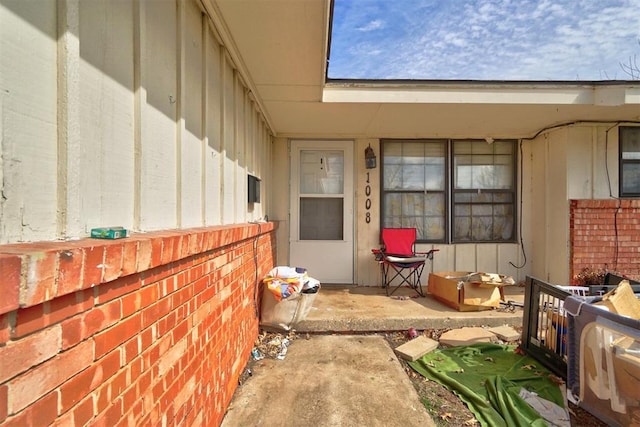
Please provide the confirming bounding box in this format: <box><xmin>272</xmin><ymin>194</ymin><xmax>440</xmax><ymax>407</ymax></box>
<box><xmin>222</xmin><ymin>335</ymin><xmax>434</xmax><ymax>427</ymax></box>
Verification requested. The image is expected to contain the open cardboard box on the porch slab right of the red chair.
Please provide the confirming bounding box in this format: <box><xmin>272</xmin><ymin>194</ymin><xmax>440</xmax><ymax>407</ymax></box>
<box><xmin>427</xmin><ymin>271</ymin><xmax>510</xmax><ymax>311</ymax></box>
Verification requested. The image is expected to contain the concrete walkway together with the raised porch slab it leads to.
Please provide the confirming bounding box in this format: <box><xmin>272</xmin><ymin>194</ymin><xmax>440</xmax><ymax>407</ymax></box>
<box><xmin>222</xmin><ymin>285</ymin><xmax>524</xmax><ymax>427</ymax></box>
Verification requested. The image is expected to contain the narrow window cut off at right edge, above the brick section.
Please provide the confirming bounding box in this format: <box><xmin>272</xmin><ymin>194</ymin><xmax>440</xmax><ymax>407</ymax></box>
<box><xmin>619</xmin><ymin>126</ymin><xmax>640</xmax><ymax>197</ymax></box>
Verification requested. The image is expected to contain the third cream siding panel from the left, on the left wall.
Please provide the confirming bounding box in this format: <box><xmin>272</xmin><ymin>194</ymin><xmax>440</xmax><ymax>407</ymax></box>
<box><xmin>137</xmin><ymin>1</ymin><xmax>178</xmax><ymax>230</ymax></box>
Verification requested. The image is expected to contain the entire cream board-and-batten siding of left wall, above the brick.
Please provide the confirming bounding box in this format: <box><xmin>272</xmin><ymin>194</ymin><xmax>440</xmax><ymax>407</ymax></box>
<box><xmin>0</xmin><ymin>0</ymin><xmax>271</xmax><ymax>244</ymax></box>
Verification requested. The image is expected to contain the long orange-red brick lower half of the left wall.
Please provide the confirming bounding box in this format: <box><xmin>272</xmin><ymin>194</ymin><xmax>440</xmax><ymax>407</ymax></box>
<box><xmin>0</xmin><ymin>223</ymin><xmax>276</xmax><ymax>426</ymax></box>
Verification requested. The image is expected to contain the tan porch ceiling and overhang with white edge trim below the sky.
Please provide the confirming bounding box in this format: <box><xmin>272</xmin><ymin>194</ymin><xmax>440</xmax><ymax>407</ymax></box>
<box><xmin>208</xmin><ymin>0</ymin><xmax>640</xmax><ymax>138</ymax></box>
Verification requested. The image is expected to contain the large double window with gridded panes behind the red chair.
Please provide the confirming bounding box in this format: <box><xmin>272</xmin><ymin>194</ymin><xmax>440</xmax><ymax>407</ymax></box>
<box><xmin>381</xmin><ymin>139</ymin><xmax>516</xmax><ymax>243</ymax></box>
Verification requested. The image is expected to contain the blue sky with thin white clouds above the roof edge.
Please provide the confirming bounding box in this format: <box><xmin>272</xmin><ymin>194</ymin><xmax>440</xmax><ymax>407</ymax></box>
<box><xmin>328</xmin><ymin>0</ymin><xmax>640</xmax><ymax>81</ymax></box>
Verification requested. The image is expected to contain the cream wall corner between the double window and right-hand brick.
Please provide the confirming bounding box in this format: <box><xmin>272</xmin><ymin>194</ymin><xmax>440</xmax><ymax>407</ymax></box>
<box><xmin>524</xmin><ymin>124</ymin><xmax>618</xmax><ymax>284</ymax></box>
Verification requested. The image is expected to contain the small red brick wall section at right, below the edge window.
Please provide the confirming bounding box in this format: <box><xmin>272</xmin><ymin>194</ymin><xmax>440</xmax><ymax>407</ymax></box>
<box><xmin>569</xmin><ymin>199</ymin><xmax>640</xmax><ymax>280</ymax></box>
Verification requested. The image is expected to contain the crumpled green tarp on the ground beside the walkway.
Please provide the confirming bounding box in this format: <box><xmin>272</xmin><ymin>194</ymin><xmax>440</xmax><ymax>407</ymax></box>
<box><xmin>409</xmin><ymin>343</ymin><xmax>564</xmax><ymax>427</ymax></box>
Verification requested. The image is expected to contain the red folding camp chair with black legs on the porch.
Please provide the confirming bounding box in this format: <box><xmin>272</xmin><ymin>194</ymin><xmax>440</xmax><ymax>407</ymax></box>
<box><xmin>372</xmin><ymin>228</ymin><xmax>438</xmax><ymax>296</ymax></box>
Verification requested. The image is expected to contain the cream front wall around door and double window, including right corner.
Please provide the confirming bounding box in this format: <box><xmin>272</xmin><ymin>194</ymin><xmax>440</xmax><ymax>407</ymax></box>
<box><xmin>273</xmin><ymin>125</ymin><xmax>618</xmax><ymax>286</ymax></box>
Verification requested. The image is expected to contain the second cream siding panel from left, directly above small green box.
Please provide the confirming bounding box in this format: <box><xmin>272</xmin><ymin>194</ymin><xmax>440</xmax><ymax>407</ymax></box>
<box><xmin>80</xmin><ymin>2</ymin><xmax>135</xmax><ymax>231</ymax></box>
